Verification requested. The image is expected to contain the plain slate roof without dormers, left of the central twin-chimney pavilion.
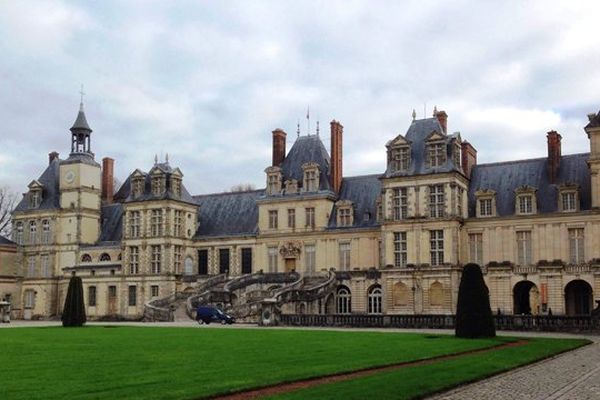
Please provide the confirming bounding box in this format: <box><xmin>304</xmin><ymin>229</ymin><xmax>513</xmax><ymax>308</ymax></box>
<box><xmin>194</xmin><ymin>190</ymin><xmax>264</xmax><ymax>238</ymax></box>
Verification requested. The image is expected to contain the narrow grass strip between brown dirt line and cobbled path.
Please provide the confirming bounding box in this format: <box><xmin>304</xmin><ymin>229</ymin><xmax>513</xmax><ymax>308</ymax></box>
<box><xmin>268</xmin><ymin>339</ymin><xmax>589</xmax><ymax>400</ymax></box>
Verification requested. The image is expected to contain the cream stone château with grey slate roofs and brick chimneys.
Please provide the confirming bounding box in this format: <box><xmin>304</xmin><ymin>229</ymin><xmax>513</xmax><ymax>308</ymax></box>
<box><xmin>0</xmin><ymin>106</ymin><xmax>600</xmax><ymax>319</ymax></box>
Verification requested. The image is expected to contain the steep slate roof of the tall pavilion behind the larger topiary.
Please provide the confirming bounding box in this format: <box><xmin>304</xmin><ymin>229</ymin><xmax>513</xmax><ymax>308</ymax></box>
<box><xmin>384</xmin><ymin>118</ymin><xmax>461</xmax><ymax>178</ymax></box>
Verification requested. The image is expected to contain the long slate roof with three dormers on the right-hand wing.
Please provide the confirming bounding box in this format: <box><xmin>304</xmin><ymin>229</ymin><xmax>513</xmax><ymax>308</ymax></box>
<box><xmin>469</xmin><ymin>153</ymin><xmax>591</xmax><ymax>217</ymax></box>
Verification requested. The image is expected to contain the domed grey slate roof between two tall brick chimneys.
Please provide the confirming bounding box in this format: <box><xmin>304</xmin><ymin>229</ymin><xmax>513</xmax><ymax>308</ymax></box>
<box><xmin>281</xmin><ymin>135</ymin><xmax>332</xmax><ymax>191</ymax></box>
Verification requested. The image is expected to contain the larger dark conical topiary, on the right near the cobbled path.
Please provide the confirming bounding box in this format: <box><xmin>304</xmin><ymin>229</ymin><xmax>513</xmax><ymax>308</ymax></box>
<box><xmin>456</xmin><ymin>264</ymin><xmax>496</xmax><ymax>338</ymax></box>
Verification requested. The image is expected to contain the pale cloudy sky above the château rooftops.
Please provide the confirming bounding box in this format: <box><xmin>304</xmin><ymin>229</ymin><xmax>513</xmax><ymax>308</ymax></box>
<box><xmin>0</xmin><ymin>0</ymin><xmax>600</xmax><ymax>194</ymax></box>
